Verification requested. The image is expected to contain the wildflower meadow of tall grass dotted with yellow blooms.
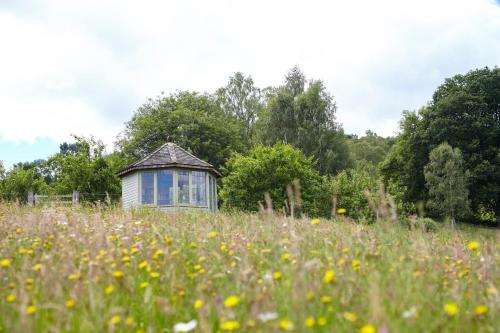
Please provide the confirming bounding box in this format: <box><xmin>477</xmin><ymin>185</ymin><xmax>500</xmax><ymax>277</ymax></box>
<box><xmin>0</xmin><ymin>204</ymin><xmax>500</xmax><ymax>333</ymax></box>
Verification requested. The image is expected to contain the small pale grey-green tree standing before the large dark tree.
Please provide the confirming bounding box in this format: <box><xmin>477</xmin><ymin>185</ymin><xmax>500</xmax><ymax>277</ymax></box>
<box><xmin>424</xmin><ymin>143</ymin><xmax>469</xmax><ymax>229</ymax></box>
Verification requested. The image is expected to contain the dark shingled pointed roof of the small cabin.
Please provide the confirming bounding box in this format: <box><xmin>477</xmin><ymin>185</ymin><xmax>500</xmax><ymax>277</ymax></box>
<box><xmin>116</xmin><ymin>142</ymin><xmax>221</xmax><ymax>177</ymax></box>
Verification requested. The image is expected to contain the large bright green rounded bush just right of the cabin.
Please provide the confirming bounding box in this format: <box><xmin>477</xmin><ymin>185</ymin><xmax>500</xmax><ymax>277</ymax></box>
<box><xmin>220</xmin><ymin>143</ymin><xmax>331</xmax><ymax>216</ymax></box>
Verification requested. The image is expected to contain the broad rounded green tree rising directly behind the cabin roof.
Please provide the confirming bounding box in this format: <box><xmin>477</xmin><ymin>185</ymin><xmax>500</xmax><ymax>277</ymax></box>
<box><xmin>117</xmin><ymin>92</ymin><xmax>246</xmax><ymax>168</ymax></box>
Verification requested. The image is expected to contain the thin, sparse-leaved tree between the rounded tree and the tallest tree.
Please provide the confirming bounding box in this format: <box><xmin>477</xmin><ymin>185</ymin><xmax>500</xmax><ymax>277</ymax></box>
<box><xmin>216</xmin><ymin>72</ymin><xmax>263</xmax><ymax>146</ymax></box>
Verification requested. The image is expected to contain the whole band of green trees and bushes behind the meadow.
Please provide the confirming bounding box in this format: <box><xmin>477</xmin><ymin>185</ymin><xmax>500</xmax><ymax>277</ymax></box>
<box><xmin>0</xmin><ymin>67</ymin><xmax>500</xmax><ymax>221</ymax></box>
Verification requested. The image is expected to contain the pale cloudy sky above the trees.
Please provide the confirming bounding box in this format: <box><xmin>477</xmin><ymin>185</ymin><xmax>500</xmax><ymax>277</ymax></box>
<box><xmin>0</xmin><ymin>0</ymin><xmax>500</xmax><ymax>167</ymax></box>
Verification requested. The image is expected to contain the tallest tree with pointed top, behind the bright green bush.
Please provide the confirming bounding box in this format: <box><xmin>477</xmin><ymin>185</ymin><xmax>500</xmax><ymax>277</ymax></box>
<box><xmin>262</xmin><ymin>67</ymin><xmax>350</xmax><ymax>174</ymax></box>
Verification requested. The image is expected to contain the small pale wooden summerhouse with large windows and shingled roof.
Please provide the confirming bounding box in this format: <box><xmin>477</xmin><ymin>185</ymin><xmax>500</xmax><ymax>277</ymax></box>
<box><xmin>117</xmin><ymin>143</ymin><xmax>221</xmax><ymax>212</ymax></box>
